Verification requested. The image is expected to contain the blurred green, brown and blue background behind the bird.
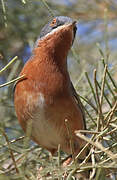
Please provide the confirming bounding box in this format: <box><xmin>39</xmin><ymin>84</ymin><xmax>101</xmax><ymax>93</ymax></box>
<box><xmin>0</xmin><ymin>0</ymin><xmax>117</xmax><ymax>179</ymax></box>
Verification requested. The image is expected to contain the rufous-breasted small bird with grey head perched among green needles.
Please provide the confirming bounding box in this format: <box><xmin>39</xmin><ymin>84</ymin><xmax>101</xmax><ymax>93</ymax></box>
<box><xmin>14</xmin><ymin>16</ymin><xmax>86</xmax><ymax>158</ymax></box>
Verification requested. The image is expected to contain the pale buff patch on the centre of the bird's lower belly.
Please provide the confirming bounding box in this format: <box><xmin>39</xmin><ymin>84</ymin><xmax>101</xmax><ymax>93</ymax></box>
<box><xmin>32</xmin><ymin>108</ymin><xmax>64</xmax><ymax>149</ymax></box>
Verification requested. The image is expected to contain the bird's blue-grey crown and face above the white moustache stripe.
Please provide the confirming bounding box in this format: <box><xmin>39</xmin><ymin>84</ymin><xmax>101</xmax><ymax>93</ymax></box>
<box><xmin>39</xmin><ymin>16</ymin><xmax>77</xmax><ymax>39</ymax></box>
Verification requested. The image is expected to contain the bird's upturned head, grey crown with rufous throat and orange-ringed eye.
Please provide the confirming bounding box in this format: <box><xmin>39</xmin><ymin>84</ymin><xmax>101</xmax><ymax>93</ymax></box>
<box><xmin>36</xmin><ymin>16</ymin><xmax>77</xmax><ymax>52</ymax></box>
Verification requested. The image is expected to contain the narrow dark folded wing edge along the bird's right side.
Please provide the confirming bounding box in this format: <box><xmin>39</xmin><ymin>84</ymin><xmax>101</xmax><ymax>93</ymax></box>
<box><xmin>71</xmin><ymin>82</ymin><xmax>86</xmax><ymax>129</ymax></box>
